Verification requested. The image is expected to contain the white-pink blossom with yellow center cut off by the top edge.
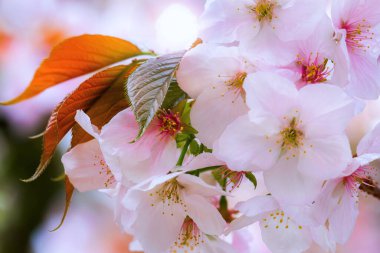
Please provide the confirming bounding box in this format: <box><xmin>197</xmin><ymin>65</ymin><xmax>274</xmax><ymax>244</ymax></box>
<box><xmin>200</xmin><ymin>0</ymin><xmax>326</xmax><ymax>61</ymax></box>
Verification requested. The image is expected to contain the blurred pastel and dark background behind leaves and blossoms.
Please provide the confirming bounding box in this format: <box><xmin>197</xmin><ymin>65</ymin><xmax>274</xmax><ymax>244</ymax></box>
<box><xmin>0</xmin><ymin>0</ymin><xmax>380</xmax><ymax>253</ymax></box>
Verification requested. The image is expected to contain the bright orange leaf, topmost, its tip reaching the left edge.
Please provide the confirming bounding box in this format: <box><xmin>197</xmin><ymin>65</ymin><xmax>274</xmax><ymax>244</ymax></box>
<box><xmin>0</xmin><ymin>35</ymin><xmax>143</xmax><ymax>105</ymax></box>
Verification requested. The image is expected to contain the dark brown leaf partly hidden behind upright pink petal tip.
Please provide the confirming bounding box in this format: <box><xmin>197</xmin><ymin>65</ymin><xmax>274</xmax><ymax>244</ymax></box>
<box><xmin>71</xmin><ymin>60</ymin><xmax>143</xmax><ymax>147</ymax></box>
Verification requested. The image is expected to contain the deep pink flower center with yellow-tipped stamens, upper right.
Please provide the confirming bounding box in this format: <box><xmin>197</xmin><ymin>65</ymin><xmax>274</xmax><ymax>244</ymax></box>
<box><xmin>297</xmin><ymin>53</ymin><xmax>332</xmax><ymax>84</ymax></box>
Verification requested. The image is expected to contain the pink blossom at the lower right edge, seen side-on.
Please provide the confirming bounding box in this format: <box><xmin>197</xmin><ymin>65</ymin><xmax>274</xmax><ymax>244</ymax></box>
<box><xmin>315</xmin><ymin>122</ymin><xmax>380</xmax><ymax>244</ymax></box>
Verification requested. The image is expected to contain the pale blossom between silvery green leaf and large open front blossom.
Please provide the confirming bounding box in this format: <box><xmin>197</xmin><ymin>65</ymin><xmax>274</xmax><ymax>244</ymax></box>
<box><xmin>177</xmin><ymin>44</ymin><xmax>253</xmax><ymax>148</ymax></box>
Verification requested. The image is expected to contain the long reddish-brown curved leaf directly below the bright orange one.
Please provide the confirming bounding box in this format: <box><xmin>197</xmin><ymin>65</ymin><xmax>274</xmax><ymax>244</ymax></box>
<box><xmin>24</xmin><ymin>65</ymin><xmax>134</xmax><ymax>182</ymax></box>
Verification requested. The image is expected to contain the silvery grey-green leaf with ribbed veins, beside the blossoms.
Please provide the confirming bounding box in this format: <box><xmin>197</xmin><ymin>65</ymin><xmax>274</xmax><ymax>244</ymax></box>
<box><xmin>126</xmin><ymin>51</ymin><xmax>185</xmax><ymax>140</ymax></box>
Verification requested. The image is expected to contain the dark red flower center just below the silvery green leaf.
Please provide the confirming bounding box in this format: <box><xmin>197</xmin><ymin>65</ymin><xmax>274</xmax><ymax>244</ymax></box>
<box><xmin>157</xmin><ymin>110</ymin><xmax>183</xmax><ymax>136</ymax></box>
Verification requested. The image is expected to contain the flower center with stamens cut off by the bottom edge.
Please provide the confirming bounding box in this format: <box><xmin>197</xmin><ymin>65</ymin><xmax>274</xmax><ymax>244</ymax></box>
<box><xmin>170</xmin><ymin>216</ymin><xmax>204</xmax><ymax>253</ymax></box>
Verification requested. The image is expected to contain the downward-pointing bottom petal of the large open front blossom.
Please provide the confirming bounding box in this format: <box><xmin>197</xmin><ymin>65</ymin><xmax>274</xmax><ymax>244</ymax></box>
<box><xmin>264</xmin><ymin>157</ymin><xmax>323</xmax><ymax>205</ymax></box>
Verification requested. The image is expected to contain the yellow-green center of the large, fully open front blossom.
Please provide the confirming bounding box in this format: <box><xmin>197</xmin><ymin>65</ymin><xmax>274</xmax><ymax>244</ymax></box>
<box><xmin>280</xmin><ymin>117</ymin><xmax>304</xmax><ymax>151</ymax></box>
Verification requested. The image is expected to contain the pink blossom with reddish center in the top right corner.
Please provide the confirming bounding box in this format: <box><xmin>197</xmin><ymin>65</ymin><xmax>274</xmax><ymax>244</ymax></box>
<box><xmin>332</xmin><ymin>0</ymin><xmax>380</xmax><ymax>99</ymax></box>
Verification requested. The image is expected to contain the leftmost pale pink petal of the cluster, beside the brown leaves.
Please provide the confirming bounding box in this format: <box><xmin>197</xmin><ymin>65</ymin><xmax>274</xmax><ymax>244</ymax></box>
<box><xmin>62</xmin><ymin>139</ymin><xmax>115</xmax><ymax>191</ymax></box>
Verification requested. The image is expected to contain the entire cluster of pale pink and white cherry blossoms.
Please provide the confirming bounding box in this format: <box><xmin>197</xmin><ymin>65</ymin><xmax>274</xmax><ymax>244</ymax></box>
<box><xmin>62</xmin><ymin>0</ymin><xmax>380</xmax><ymax>253</ymax></box>
